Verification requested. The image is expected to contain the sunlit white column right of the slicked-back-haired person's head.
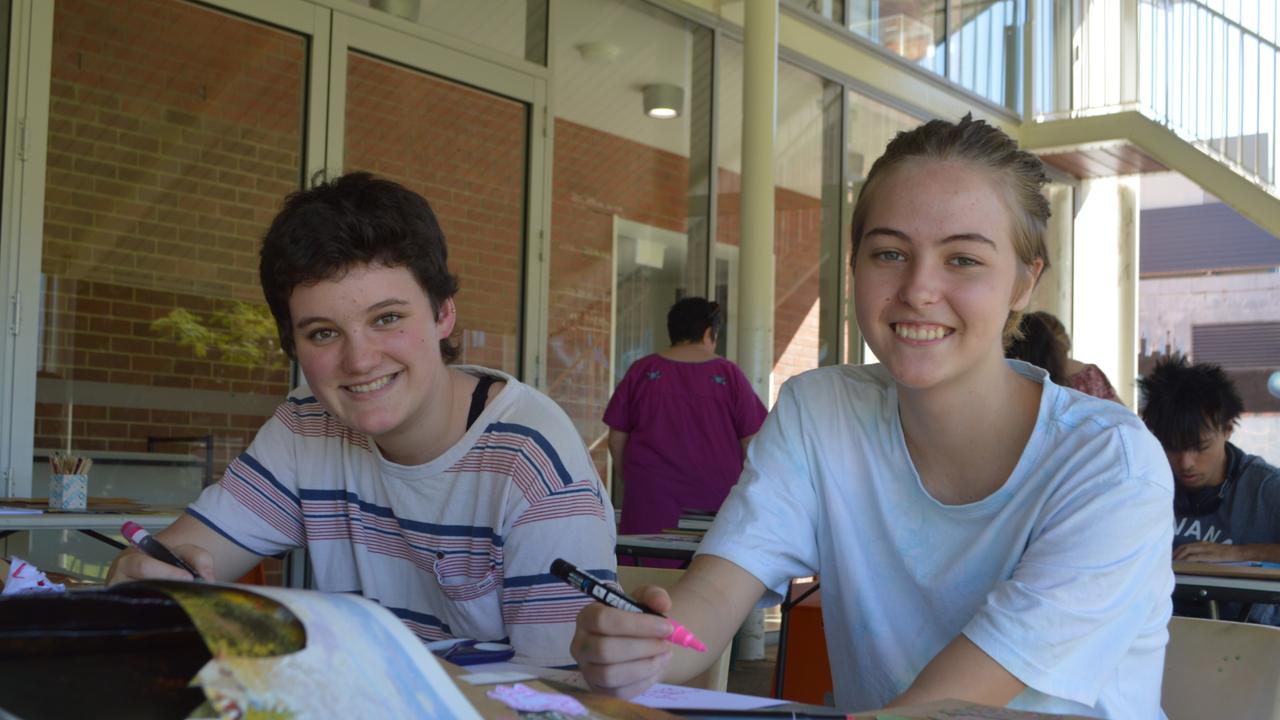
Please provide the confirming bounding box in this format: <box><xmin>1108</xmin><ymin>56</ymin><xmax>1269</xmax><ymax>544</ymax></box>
<box><xmin>1069</xmin><ymin>176</ymin><xmax>1138</xmax><ymax>407</ymax></box>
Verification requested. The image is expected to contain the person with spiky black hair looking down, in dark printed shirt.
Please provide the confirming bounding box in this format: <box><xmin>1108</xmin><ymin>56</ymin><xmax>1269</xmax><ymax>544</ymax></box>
<box><xmin>1139</xmin><ymin>356</ymin><xmax>1280</xmax><ymax>625</ymax></box>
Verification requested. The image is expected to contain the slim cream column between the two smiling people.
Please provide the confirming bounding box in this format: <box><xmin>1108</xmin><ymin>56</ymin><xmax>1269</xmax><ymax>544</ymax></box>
<box><xmin>737</xmin><ymin>0</ymin><xmax>778</xmax><ymax>405</ymax></box>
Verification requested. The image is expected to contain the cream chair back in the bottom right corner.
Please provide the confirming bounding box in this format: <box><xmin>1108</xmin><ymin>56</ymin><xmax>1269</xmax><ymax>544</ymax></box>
<box><xmin>1160</xmin><ymin>609</ymin><xmax>1280</xmax><ymax>720</ymax></box>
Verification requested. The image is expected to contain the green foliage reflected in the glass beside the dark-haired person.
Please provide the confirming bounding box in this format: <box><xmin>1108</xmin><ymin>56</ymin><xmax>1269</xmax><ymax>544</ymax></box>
<box><xmin>151</xmin><ymin>300</ymin><xmax>285</xmax><ymax>368</ymax></box>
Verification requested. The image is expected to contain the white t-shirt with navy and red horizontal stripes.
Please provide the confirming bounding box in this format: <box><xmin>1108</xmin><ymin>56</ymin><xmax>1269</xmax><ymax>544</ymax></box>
<box><xmin>187</xmin><ymin>366</ymin><xmax>617</xmax><ymax>666</ymax></box>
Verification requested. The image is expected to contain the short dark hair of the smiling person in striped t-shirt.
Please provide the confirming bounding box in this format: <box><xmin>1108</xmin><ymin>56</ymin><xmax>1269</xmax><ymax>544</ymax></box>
<box><xmin>259</xmin><ymin>172</ymin><xmax>458</xmax><ymax>363</ymax></box>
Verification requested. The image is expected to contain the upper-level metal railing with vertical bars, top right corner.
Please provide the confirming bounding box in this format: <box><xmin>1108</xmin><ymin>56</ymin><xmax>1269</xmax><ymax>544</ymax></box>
<box><xmin>1033</xmin><ymin>0</ymin><xmax>1280</xmax><ymax>193</ymax></box>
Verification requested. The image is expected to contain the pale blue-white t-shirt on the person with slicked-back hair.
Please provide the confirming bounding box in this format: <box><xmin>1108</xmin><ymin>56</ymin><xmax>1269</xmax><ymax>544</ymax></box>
<box><xmin>700</xmin><ymin>361</ymin><xmax>1174</xmax><ymax>720</ymax></box>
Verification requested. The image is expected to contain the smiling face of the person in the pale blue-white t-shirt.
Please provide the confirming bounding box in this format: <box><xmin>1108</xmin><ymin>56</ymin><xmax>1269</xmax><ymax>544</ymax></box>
<box><xmin>854</xmin><ymin>159</ymin><xmax>1041</xmax><ymax>389</ymax></box>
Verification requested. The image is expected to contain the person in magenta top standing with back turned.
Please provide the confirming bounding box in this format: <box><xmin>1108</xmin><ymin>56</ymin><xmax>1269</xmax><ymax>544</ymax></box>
<box><xmin>604</xmin><ymin>297</ymin><xmax>767</xmax><ymax>534</ymax></box>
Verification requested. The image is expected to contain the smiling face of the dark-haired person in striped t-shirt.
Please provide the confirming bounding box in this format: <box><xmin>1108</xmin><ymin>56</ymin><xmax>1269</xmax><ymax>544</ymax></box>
<box><xmin>289</xmin><ymin>260</ymin><xmax>456</xmax><ymax>450</ymax></box>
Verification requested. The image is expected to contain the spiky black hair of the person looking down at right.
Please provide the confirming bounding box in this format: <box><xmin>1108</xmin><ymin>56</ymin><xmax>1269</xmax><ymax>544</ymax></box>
<box><xmin>1138</xmin><ymin>355</ymin><xmax>1244</xmax><ymax>452</ymax></box>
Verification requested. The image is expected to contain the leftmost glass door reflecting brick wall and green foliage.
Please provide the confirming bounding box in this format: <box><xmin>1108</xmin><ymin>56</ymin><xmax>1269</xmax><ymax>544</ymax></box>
<box><xmin>0</xmin><ymin>0</ymin><xmax>329</xmax><ymax>578</ymax></box>
